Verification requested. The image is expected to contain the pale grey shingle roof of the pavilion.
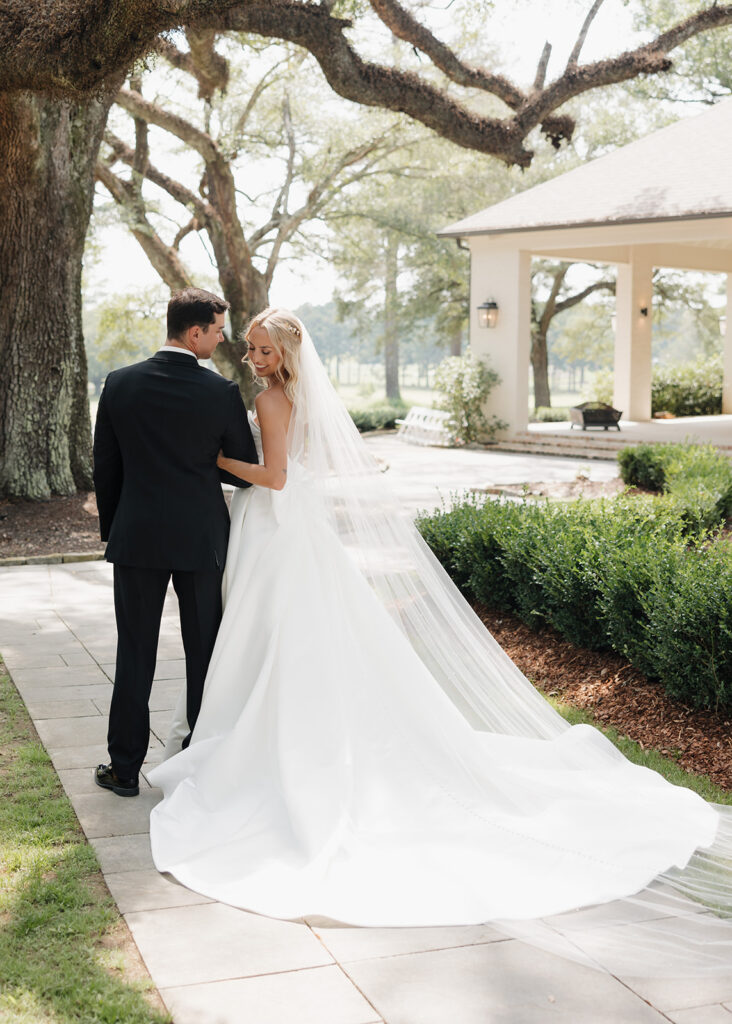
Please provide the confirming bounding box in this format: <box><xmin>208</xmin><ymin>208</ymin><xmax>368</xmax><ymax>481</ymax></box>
<box><xmin>439</xmin><ymin>99</ymin><xmax>732</xmax><ymax>237</ymax></box>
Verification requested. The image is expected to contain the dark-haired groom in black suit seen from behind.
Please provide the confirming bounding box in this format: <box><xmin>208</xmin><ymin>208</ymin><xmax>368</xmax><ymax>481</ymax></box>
<box><xmin>94</xmin><ymin>288</ymin><xmax>258</xmax><ymax>797</ymax></box>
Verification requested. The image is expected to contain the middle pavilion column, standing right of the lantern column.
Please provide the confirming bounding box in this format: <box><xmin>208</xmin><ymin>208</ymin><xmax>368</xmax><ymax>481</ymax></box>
<box><xmin>613</xmin><ymin>251</ymin><xmax>653</xmax><ymax>420</ymax></box>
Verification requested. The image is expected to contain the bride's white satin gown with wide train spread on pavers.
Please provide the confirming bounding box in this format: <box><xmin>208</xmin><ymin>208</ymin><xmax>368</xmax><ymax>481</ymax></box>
<box><xmin>149</xmin><ymin>411</ymin><xmax>718</xmax><ymax>926</ymax></box>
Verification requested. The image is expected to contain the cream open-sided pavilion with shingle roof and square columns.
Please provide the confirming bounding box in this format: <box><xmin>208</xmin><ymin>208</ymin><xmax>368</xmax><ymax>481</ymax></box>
<box><xmin>439</xmin><ymin>100</ymin><xmax>732</xmax><ymax>443</ymax></box>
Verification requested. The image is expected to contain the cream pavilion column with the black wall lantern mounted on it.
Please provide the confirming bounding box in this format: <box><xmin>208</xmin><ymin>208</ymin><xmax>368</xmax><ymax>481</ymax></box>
<box><xmin>470</xmin><ymin>238</ymin><xmax>531</xmax><ymax>436</ymax></box>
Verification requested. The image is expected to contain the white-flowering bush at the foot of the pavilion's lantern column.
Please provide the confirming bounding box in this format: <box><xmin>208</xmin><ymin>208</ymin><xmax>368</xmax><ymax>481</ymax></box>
<box><xmin>435</xmin><ymin>352</ymin><xmax>507</xmax><ymax>444</ymax></box>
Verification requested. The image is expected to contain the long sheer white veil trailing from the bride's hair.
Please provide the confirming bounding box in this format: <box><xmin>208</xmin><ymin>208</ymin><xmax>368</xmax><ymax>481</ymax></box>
<box><xmin>288</xmin><ymin>319</ymin><xmax>732</xmax><ymax>976</ymax></box>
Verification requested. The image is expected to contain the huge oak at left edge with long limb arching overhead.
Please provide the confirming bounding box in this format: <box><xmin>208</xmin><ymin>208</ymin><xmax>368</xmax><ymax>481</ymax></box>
<box><xmin>0</xmin><ymin>0</ymin><xmax>732</xmax><ymax>498</ymax></box>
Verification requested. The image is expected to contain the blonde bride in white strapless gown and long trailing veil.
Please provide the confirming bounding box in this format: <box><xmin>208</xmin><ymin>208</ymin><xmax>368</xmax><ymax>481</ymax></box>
<box><xmin>149</xmin><ymin>308</ymin><xmax>732</xmax><ymax>974</ymax></box>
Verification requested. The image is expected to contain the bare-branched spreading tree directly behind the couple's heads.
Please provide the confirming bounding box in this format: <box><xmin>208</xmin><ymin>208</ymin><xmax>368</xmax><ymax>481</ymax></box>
<box><xmin>96</xmin><ymin>31</ymin><xmax>399</xmax><ymax>400</ymax></box>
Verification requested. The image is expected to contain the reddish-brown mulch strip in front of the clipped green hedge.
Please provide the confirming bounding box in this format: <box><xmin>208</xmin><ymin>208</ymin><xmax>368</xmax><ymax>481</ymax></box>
<box><xmin>476</xmin><ymin>607</ymin><xmax>732</xmax><ymax>790</ymax></box>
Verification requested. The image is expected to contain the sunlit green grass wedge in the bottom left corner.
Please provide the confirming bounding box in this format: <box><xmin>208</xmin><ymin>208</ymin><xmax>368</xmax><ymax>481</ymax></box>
<box><xmin>0</xmin><ymin>660</ymin><xmax>171</xmax><ymax>1024</ymax></box>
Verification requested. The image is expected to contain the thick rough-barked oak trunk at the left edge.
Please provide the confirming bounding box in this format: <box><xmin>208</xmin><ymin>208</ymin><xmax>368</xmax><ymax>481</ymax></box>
<box><xmin>0</xmin><ymin>90</ymin><xmax>118</xmax><ymax>499</ymax></box>
